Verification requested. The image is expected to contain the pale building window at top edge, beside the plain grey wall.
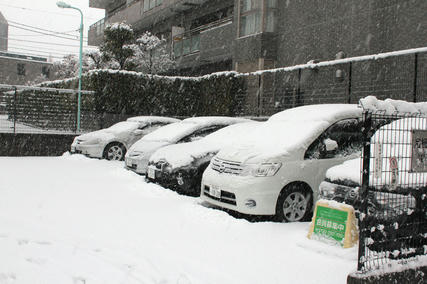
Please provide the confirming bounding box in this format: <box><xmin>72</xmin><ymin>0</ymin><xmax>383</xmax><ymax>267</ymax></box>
<box><xmin>239</xmin><ymin>0</ymin><xmax>277</xmax><ymax>37</ymax></box>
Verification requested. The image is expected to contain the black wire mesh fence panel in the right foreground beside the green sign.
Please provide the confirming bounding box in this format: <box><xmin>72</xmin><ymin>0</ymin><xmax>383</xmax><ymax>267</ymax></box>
<box><xmin>358</xmin><ymin>111</ymin><xmax>427</xmax><ymax>272</ymax></box>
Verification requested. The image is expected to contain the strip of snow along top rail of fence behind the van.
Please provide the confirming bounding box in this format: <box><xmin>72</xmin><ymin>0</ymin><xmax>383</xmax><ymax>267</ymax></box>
<box><xmin>246</xmin><ymin>47</ymin><xmax>427</xmax><ymax>75</ymax></box>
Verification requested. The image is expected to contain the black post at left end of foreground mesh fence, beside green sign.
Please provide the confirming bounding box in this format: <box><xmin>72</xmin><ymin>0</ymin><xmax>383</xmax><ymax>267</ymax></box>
<box><xmin>357</xmin><ymin>111</ymin><xmax>372</xmax><ymax>271</ymax></box>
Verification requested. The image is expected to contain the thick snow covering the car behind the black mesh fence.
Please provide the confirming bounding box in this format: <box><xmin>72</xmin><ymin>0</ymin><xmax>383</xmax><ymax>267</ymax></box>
<box><xmin>326</xmin><ymin>117</ymin><xmax>427</xmax><ymax>187</ymax></box>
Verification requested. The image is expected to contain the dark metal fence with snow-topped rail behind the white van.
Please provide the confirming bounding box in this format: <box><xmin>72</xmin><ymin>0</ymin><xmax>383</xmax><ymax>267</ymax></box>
<box><xmin>247</xmin><ymin>47</ymin><xmax>427</xmax><ymax>115</ymax></box>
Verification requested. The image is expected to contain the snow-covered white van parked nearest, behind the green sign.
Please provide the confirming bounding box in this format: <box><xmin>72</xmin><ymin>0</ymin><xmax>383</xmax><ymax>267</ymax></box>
<box><xmin>201</xmin><ymin>104</ymin><xmax>363</xmax><ymax>222</ymax></box>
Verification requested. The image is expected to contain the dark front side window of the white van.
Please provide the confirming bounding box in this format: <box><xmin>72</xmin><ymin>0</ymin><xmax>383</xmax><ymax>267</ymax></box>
<box><xmin>304</xmin><ymin>119</ymin><xmax>364</xmax><ymax>159</ymax></box>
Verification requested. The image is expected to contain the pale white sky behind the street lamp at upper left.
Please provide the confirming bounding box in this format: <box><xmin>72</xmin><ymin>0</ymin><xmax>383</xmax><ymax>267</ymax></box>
<box><xmin>0</xmin><ymin>0</ymin><xmax>105</xmax><ymax>60</ymax></box>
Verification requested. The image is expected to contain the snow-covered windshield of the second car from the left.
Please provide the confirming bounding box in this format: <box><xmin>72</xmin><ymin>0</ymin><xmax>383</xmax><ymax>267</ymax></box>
<box><xmin>141</xmin><ymin>121</ymin><xmax>198</xmax><ymax>143</ymax></box>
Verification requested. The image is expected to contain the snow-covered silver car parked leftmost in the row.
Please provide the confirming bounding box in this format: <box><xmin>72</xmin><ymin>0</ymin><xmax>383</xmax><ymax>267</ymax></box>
<box><xmin>71</xmin><ymin>116</ymin><xmax>180</xmax><ymax>160</ymax></box>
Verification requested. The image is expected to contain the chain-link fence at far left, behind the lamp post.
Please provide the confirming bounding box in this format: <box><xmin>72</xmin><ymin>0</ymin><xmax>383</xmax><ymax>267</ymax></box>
<box><xmin>0</xmin><ymin>85</ymin><xmax>134</xmax><ymax>134</ymax></box>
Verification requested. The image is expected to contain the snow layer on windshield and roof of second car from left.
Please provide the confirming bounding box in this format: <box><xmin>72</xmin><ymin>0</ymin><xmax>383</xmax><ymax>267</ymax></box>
<box><xmin>141</xmin><ymin>116</ymin><xmax>250</xmax><ymax>143</ymax></box>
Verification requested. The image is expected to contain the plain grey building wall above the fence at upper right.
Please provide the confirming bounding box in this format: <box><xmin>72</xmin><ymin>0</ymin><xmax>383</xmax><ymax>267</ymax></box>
<box><xmin>277</xmin><ymin>0</ymin><xmax>427</xmax><ymax>66</ymax></box>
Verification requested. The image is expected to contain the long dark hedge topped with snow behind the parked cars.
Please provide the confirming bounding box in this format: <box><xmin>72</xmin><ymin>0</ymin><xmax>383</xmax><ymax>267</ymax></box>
<box><xmin>87</xmin><ymin>70</ymin><xmax>243</xmax><ymax>116</ymax></box>
